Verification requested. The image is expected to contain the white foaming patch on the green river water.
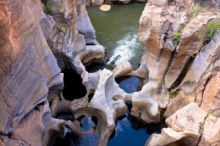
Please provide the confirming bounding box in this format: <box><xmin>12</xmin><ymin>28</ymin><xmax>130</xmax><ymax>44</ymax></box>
<box><xmin>107</xmin><ymin>33</ymin><xmax>140</xmax><ymax>64</ymax></box>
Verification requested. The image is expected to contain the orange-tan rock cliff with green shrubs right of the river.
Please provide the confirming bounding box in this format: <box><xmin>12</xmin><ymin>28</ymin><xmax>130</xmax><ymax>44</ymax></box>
<box><xmin>131</xmin><ymin>0</ymin><xmax>220</xmax><ymax>146</ymax></box>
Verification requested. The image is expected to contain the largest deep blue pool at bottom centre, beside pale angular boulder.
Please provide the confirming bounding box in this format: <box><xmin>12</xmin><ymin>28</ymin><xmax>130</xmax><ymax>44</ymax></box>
<box><xmin>108</xmin><ymin>106</ymin><xmax>165</xmax><ymax>146</ymax></box>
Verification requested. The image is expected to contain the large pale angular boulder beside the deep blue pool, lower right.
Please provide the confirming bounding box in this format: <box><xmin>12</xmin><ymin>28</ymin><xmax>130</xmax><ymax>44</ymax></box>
<box><xmin>145</xmin><ymin>103</ymin><xmax>207</xmax><ymax>146</ymax></box>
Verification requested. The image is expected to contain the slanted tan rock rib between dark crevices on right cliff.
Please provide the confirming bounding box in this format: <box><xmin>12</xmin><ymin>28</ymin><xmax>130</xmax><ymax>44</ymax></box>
<box><xmin>165</xmin><ymin>12</ymin><xmax>218</xmax><ymax>88</ymax></box>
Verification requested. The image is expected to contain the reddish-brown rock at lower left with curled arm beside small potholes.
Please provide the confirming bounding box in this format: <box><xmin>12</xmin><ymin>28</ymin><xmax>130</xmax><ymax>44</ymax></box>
<box><xmin>5</xmin><ymin>101</ymin><xmax>92</xmax><ymax>146</ymax></box>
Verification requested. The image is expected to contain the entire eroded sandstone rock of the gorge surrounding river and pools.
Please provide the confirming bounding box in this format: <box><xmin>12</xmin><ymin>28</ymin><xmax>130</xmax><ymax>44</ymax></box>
<box><xmin>0</xmin><ymin>0</ymin><xmax>220</xmax><ymax>146</ymax></box>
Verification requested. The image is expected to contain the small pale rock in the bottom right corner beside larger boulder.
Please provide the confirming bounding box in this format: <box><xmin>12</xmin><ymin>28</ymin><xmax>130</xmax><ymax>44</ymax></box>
<box><xmin>199</xmin><ymin>115</ymin><xmax>220</xmax><ymax>146</ymax></box>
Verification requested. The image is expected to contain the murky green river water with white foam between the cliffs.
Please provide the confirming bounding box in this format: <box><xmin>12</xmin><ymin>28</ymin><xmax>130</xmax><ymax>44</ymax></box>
<box><xmin>86</xmin><ymin>3</ymin><xmax>145</xmax><ymax>70</ymax></box>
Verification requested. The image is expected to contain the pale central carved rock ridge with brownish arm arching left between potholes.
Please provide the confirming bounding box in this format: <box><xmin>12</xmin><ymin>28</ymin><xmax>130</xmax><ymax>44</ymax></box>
<box><xmin>51</xmin><ymin>69</ymin><xmax>129</xmax><ymax>146</ymax></box>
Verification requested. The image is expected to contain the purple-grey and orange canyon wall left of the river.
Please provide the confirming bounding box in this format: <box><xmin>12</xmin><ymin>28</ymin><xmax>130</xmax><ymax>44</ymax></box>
<box><xmin>0</xmin><ymin>0</ymin><xmax>105</xmax><ymax>146</ymax></box>
